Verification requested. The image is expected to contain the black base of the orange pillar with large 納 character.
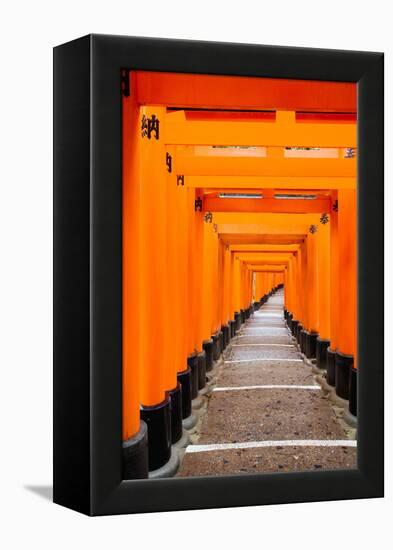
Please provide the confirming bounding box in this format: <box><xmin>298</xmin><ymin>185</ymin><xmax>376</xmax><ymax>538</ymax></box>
<box><xmin>141</xmin><ymin>399</ymin><xmax>172</xmax><ymax>471</ymax></box>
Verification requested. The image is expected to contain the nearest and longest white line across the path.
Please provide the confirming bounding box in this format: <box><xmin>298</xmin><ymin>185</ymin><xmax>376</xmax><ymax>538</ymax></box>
<box><xmin>186</xmin><ymin>439</ymin><xmax>357</xmax><ymax>453</ymax></box>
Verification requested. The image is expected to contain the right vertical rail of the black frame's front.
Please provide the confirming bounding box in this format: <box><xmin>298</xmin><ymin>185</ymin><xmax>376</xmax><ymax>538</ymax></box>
<box><xmin>357</xmin><ymin>53</ymin><xmax>384</xmax><ymax>497</ymax></box>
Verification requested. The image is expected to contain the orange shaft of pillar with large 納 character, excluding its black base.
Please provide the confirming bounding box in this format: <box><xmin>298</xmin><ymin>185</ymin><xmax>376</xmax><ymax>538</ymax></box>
<box><xmin>138</xmin><ymin>106</ymin><xmax>169</xmax><ymax>406</ymax></box>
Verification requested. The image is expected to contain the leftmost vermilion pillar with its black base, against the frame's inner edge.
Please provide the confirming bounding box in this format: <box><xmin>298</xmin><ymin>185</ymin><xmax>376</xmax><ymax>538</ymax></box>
<box><xmin>122</xmin><ymin>76</ymin><xmax>148</xmax><ymax>479</ymax></box>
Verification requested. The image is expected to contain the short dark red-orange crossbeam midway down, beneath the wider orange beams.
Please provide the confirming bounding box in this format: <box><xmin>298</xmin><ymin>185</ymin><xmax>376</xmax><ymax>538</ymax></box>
<box><xmin>203</xmin><ymin>197</ymin><xmax>331</xmax><ymax>214</ymax></box>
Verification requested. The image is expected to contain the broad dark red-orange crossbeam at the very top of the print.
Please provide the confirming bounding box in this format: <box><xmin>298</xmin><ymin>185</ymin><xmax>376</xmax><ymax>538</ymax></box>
<box><xmin>131</xmin><ymin>71</ymin><xmax>356</xmax><ymax>113</ymax></box>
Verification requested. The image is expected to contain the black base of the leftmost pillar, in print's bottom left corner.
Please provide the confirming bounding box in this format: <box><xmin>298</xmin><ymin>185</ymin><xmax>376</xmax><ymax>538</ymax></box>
<box><xmin>122</xmin><ymin>421</ymin><xmax>149</xmax><ymax>479</ymax></box>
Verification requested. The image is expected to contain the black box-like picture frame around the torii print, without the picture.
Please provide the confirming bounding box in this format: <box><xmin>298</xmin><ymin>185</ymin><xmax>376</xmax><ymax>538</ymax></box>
<box><xmin>54</xmin><ymin>35</ymin><xmax>384</xmax><ymax>515</ymax></box>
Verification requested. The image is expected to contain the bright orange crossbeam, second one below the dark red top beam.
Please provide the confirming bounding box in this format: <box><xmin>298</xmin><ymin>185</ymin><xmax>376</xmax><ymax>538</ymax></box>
<box><xmin>175</xmin><ymin>155</ymin><xmax>357</xmax><ymax>177</ymax></box>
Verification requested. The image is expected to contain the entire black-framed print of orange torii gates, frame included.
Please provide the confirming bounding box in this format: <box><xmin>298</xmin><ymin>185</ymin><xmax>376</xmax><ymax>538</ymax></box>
<box><xmin>54</xmin><ymin>35</ymin><xmax>383</xmax><ymax>515</ymax></box>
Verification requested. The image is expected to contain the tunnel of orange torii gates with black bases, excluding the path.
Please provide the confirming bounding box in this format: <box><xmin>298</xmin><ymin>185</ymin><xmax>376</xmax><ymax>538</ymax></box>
<box><xmin>122</xmin><ymin>70</ymin><xmax>357</xmax><ymax>479</ymax></box>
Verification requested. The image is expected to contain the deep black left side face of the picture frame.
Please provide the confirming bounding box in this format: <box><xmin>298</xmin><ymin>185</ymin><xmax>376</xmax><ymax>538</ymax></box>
<box><xmin>53</xmin><ymin>36</ymin><xmax>91</xmax><ymax>514</ymax></box>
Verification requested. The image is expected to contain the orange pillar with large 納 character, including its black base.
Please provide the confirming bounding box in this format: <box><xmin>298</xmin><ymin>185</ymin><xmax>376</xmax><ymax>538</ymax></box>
<box><xmin>138</xmin><ymin>106</ymin><xmax>171</xmax><ymax>470</ymax></box>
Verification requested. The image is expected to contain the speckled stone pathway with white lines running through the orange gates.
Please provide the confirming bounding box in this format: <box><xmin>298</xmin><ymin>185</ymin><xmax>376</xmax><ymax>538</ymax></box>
<box><xmin>177</xmin><ymin>291</ymin><xmax>356</xmax><ymax>477</ymax></box>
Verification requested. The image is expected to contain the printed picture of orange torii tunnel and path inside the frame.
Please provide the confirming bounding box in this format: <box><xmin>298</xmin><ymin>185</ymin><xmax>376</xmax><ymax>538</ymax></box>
<box><xmin>121</xmin><ymin>69</ymin><xmax>357</xmax><ymax>479</ymax></box>
